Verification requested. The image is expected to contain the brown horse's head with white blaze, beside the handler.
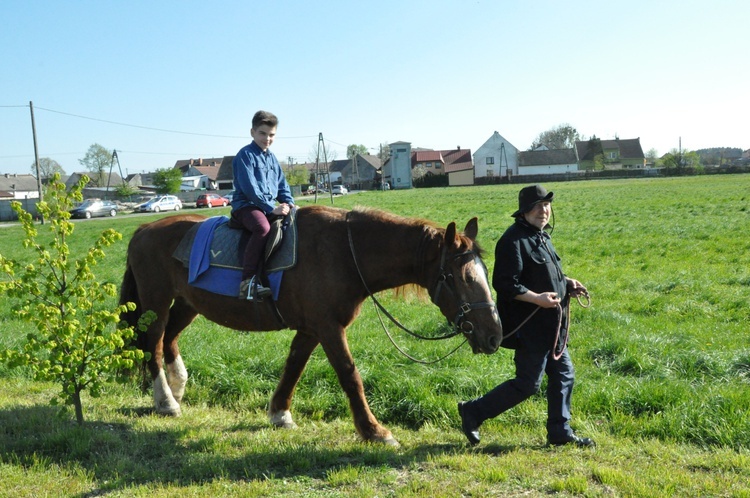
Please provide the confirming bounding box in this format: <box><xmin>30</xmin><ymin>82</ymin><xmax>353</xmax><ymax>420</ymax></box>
<box><xmin>429</xmin><ymin>218</ymin><xmax>503</xmax><ymax>354</ymax></box>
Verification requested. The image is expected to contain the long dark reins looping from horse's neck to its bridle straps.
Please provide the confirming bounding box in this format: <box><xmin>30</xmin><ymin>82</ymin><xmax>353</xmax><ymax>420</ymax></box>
<box><xmin>346</xmin><ymin>211</ymin><xmax>495</xmax><ymax>365</ymax></box>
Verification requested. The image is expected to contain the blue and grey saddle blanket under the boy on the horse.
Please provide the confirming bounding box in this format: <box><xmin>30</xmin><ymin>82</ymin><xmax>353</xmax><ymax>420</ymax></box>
<box><xmin>172</xmin><ymin>210</ymin><xmax>297</xmax><ymax>301</ymax></box>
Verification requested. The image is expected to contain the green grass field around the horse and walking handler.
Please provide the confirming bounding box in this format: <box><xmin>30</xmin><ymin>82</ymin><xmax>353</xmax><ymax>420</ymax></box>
<box><xmin>0</xmin><ymin>175</ymin><xmax>750</xmax><ymax>497</ymax></box>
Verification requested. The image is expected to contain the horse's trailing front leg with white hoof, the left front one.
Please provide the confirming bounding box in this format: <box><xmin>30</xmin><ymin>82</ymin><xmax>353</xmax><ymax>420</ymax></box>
<box><xmin>268</xmin><ymin>330</ymin><xmax>318</xmax><ymax>429</ymax></box>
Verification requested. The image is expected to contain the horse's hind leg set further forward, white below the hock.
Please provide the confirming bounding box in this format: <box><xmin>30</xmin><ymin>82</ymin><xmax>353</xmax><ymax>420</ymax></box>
<box><xmin>163</xmin><ymin>297</ymin><xmax>198</xmax><ymax>404</ymax></box>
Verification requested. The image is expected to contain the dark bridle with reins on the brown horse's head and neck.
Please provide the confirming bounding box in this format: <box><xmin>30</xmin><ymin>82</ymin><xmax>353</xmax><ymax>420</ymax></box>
<box><xmin>346</xmin><ymin>212</ymin><xmax>495</xmax><ymax>350</ymax></box>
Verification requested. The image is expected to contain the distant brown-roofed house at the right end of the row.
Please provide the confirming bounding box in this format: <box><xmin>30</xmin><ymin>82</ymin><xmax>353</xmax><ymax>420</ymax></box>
<box><xmin>575</xmin><ymin>138</ymin><xmax>646</xmax><ymax>170</ymax></box>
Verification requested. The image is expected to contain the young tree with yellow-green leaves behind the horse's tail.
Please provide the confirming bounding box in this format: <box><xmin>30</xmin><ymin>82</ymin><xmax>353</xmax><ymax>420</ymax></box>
<box><xmin>0</xmin><ymin>174</ymin><xmax>152</xmax><ymax>425</ymax></box>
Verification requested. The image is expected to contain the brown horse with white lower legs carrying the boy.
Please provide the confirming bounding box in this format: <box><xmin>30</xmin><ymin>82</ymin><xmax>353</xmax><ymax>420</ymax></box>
<box><xmin>120</xmin><ymin>206</ymin><xmax>502</xmax><ymax>445</ymax></box>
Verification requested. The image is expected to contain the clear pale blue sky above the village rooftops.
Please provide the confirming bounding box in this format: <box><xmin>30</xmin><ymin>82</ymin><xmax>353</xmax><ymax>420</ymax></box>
<box><xmin>0</xmin><ymin>0</ymin><xmax>750</xmax><ymax>177</ymax></box>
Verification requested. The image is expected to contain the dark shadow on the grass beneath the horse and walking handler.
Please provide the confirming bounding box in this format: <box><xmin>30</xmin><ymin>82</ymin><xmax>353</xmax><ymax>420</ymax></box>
<box><xmin>0</xmin><ymin>405</ymin><xmax>516</xmax><ymax>498</ymax></box>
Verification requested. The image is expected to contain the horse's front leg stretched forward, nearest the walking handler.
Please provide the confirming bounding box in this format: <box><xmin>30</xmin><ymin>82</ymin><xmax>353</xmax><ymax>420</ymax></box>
<box><xmin>320</xmin><ymin>328</ymin><xmax>399</xmax><ymax>446</ymax></box>
